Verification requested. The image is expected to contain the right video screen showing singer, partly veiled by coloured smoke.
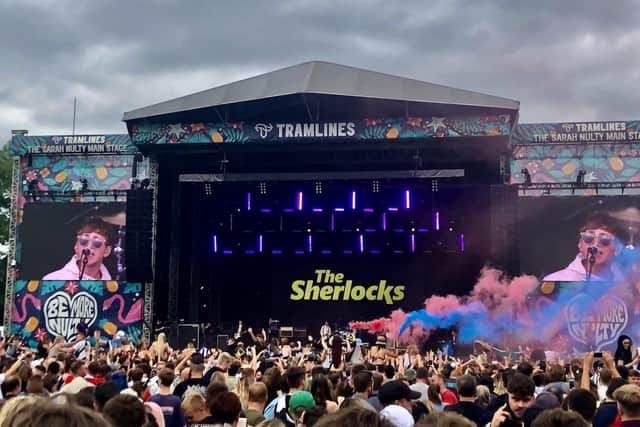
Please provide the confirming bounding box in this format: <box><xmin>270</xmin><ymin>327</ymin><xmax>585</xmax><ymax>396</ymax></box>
<box><xmin>517</xmin><ymin>196</ymin><xmax>640</xmax><ymax>282</ymax></box>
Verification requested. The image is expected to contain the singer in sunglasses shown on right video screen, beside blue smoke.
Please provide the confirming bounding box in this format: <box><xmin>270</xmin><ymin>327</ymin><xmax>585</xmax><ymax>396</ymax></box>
<box><xmin>543</xmin><ymin>213</ymin><xmax>622</xmax><ymax>282</ymax></box>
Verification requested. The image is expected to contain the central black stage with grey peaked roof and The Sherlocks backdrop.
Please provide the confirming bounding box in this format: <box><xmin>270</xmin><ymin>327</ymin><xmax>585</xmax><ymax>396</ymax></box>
<box><xmin>124</xmin><ymin>62</ymin><xmax>519</xmax><ymax>342</ymax></box>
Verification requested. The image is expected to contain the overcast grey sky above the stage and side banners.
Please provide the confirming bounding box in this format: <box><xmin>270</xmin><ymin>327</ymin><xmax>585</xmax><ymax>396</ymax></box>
<box><xmin>0</xmin><ymin>0</ymin><xmax>640</xmax><ymax>140</ymax></box>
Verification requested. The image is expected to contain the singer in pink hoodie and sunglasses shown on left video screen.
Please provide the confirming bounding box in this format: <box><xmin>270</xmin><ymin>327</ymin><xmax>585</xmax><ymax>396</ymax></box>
<box><xmin>42</xmin><ymin>217</ymin><xmax>112</xmax><ymax>280</ymax></box>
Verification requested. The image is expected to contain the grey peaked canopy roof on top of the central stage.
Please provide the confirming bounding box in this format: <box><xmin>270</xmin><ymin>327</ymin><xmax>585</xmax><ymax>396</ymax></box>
<box><xmin>123</xmin><ymin>61</ymin><xmax>520</xmax><ymax>121</ymax></box>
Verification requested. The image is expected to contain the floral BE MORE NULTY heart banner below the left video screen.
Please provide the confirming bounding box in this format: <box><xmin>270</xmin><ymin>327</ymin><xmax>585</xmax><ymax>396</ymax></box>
<box><xmin>11</xmin><ymin>280</ymin><xmax>143</xmax><ymax>347</ymax></box>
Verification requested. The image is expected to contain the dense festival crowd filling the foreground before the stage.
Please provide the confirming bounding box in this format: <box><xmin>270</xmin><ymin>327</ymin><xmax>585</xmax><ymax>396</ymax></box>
<box><xmin>0</xmin><ymin>325</ymin><xmax>640</xmax><ymax>427</ymax></box>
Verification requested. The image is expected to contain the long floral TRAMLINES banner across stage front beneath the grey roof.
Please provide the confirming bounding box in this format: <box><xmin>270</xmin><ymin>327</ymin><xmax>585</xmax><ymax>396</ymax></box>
<box><xmin>131</xmin><ymin>114</ymin><xmax>512</xmax><ymax>144</ymax></box>
